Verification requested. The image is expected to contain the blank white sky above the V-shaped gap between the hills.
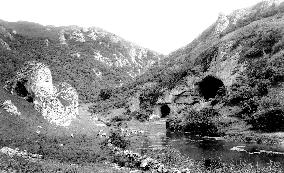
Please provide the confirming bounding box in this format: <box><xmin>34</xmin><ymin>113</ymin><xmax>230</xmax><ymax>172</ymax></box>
<box><xmin>0</xmin><ymin>0</ymin><xmax>268</xmax><ymax>55</ymax></box>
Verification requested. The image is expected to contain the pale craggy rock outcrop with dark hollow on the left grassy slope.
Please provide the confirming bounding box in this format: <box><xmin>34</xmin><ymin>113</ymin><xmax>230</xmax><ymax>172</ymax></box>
<box><xmin>4</xmin><ymin>61</ymin><xmax>78</xmax><ymax>126</ymax></box>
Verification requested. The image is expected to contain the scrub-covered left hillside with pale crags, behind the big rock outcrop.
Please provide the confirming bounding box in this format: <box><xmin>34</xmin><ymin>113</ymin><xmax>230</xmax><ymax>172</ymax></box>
<box><xmin>0</xmin><ymin>20</ymin><xmax>163</xmax><ymax>102</ymax></box>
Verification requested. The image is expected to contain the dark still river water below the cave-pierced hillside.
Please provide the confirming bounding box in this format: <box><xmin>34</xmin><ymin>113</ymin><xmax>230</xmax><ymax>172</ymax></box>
<box><xmin>137</xmin><ymin>130</ymin><xmax>284</xmax><ymax>166</ymax></box>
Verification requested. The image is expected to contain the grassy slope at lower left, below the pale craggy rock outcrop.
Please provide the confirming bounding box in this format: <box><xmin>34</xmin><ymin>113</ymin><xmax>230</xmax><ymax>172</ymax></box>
<box><xmin>0</xmin><ymin>86</ymin><xmax>121</xmax><ymax>173</ymax></box>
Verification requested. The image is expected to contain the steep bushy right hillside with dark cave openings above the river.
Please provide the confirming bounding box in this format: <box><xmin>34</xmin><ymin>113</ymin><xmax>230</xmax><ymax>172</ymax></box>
<box><xmin>91</xmin><ymin>1</ymin><xmax>284</xmax><ymax>135</ymax></box>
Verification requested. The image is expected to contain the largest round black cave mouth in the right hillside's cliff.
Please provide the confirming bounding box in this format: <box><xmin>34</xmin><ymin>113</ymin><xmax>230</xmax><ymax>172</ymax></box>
<box><xmin>198</xmin><ymin>76</ymin><xmax>225</xmax><ymax>100</ymax></box>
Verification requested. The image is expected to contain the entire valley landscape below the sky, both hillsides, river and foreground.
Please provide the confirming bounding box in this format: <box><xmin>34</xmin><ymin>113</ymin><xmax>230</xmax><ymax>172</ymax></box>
<box><xmin>0</xmin><ymin>1</ymin><xmax>284</xmax><ymax>173</ymax></box>
